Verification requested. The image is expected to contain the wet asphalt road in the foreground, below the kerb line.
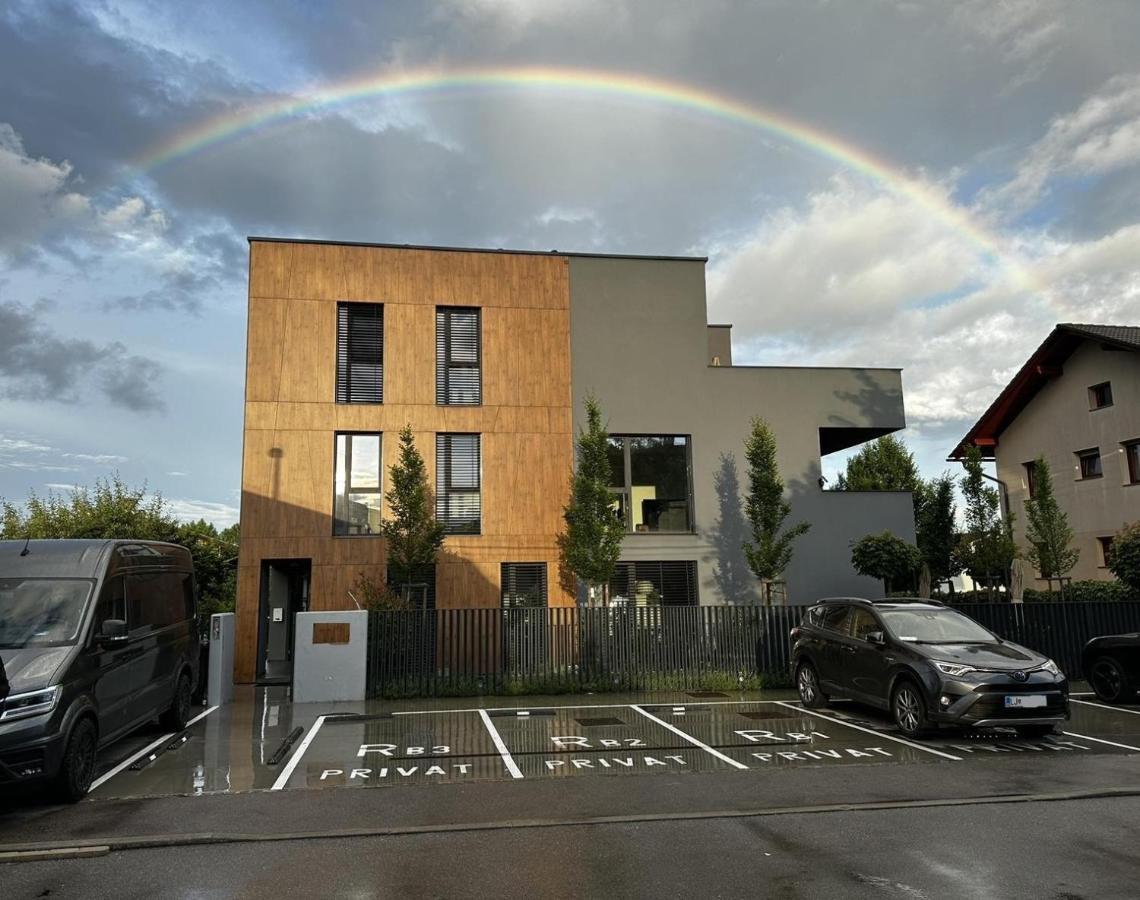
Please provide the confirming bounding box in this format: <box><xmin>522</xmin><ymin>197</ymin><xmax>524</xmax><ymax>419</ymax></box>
<box><xmin>0</xmin><ymin>797</ymin><xmax>1140</xmax><ymax>900</ymax></box>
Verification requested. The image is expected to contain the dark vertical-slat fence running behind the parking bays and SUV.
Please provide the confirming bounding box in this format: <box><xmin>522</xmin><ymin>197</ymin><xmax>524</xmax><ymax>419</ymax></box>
<box><xmin>368</xmin><ymin>602</ymin><xmax>1140</xmax><ymax>697</ymax></box>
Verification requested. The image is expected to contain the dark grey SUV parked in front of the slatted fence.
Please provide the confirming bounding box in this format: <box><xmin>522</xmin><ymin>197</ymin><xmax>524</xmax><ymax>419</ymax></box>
<box><xmin>791</xmin><ymin>598</ymin><xmax>1069</xmax><ymax>737</ymax></box>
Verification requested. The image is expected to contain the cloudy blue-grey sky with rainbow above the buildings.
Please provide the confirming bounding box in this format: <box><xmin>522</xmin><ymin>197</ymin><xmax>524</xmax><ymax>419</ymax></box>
<box><xmin>0</xmin><ymin>0</ymin><xmax>1140</xmax><ymax>526</ymax></box>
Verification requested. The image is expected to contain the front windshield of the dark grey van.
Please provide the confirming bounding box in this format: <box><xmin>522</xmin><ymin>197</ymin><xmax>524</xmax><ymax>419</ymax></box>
<box><xmin>0</xmin><ymin>577</ymin><xmax>91</xmax><ymax>650</ymax></box>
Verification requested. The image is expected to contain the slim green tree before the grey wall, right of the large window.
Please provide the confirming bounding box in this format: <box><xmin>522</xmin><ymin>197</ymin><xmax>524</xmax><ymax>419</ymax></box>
<box><xmin>743</xmin><ymin>416</ymin><xmax>812</xmax><ymax>605</ymax></box>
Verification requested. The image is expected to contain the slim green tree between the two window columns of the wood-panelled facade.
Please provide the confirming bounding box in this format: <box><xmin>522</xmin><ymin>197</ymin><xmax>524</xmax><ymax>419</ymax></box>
<box><xmin>381</xmin><ymin>425</ymin><xmax>443</xmax><ymax>584</ymax></box>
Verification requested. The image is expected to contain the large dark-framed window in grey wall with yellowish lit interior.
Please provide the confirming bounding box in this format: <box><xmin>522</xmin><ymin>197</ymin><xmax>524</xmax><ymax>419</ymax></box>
<box><xmin>609</xmin><ymin>435</ymin><xmax>693</xmax><ymax>532</ymax></box>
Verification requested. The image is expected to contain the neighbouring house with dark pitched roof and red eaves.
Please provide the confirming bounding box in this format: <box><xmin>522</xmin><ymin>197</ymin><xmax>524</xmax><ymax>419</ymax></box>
<box><xmin>951</xmin><ymin>324</ymin><xmax>1140</xmax><ymax>586</ymax></box>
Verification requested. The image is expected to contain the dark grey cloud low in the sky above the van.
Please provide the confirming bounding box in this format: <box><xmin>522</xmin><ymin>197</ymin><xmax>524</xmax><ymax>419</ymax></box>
<box><xmin>0</xmin><ymin>301</ymin><xmax>164</xmax><ymax>412</ymax></box>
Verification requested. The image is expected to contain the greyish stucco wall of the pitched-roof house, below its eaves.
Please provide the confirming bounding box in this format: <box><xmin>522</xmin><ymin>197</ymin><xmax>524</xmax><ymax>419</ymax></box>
<box><xmin>995</xmin><ymin>341</ymin><xmax>1140</xmax><ymax>586</ymax></box>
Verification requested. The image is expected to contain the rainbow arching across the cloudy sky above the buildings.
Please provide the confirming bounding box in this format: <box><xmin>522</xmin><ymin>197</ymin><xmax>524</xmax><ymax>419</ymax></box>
<box><xmin>136</xmin><ymin>66</ymin><xmax>1032</xmax><ymax>285</ymax></box>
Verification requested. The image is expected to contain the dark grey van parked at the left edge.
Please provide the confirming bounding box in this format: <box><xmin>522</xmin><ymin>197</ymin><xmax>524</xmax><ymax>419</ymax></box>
<box><xmin>0</xmin><ymin>541</ymin><xmax>198</xmax><ymax>801</ymax></box>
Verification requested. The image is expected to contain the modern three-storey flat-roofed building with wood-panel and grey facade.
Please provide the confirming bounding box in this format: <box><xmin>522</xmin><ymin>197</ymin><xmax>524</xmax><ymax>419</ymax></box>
<box><xmin>236</xmin><ymin>238</ymin><xmax>914</xmax><ymax>681</ymax></box>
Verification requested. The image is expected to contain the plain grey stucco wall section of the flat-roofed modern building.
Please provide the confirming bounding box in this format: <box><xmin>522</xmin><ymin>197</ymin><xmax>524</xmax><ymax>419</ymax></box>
<box><xmin>570</xmin><ymin>258</ymin><xmax>914</xmax><ymax>603</ymax></box>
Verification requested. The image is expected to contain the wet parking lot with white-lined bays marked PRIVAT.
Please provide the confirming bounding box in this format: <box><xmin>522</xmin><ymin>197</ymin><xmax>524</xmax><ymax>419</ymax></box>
<box><xmin>71</xmin><ymin>688</ymin><xmax>1140</xmax><ymax>801</ymax></box>
